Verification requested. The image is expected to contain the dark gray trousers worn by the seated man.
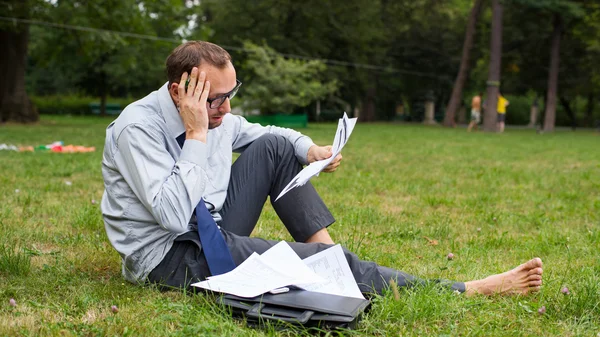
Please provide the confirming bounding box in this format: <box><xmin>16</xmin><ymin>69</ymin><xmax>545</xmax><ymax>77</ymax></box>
<box><xmin>148</xmin><ymin>134</ymin><xmax>465</xmax><ymax>294</ymax></box>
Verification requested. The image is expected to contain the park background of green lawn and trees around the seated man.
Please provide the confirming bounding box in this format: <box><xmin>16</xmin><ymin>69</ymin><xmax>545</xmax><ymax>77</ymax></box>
<box><xmin>0</xmin><ymin>0</ymin><xmax>600</xmax><ymax>336</ymax></box>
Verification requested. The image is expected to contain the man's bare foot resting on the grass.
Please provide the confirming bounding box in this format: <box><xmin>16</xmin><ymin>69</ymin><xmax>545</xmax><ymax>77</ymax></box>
<box><xmin>465</xmin><ymin>257</ymin><xmax>542</xmax><ymax>295</ymax></box>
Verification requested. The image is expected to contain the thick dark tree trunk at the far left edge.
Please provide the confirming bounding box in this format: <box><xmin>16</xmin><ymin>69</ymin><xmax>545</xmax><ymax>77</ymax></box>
<box><xmin>0</xmin><ymin>0</ymin><xmax>39</xmax><ymax>123</ymax></box>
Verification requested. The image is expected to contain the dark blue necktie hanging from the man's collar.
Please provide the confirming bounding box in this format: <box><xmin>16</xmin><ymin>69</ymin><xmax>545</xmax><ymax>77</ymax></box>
<box><xmin>177</xmin><ymin>133</ymin><xmax>235</xmax><ymax>275</ymax></box>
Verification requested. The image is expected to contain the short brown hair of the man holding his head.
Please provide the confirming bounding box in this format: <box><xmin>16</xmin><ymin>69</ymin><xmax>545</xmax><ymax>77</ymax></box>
<box><xmin>166</xmin><ymin>41</ymin><xmax>231</xmax><ymax>85</ymax></box>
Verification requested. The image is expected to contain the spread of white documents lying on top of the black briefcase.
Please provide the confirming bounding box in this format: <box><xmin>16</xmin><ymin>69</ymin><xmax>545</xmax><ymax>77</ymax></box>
<box><xmin>192</xmin><ymin>241</ymin><xmax>364</xmax><ymax>299</ymax></box>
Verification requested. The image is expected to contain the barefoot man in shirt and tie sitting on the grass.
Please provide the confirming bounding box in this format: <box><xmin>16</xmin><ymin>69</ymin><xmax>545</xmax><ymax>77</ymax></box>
<box><xmin>102</xmin><ymin>41</ymin><xmax>542</xmax><ymax>294</ymax></box>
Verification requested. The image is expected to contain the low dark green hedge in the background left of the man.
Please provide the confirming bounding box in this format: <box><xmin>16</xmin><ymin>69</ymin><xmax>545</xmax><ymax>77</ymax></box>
<box><xmin>31</xmin><ymin>95</ymin><xmax>134</xmax><ymax>115</ymax></box>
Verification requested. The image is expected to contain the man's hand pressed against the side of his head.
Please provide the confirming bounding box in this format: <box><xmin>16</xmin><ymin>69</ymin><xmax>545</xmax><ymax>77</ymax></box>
<box><xmin>177</xmin><ymin>67</ymin><xmax>210</xmax><ymax>143</ymax></box>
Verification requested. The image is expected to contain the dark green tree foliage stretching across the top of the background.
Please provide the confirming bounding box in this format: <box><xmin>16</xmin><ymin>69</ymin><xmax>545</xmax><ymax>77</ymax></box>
<box><xmin>9</xmin><ymin>0</ymin><xmax>600</xmax><ymax>120</ymax></box>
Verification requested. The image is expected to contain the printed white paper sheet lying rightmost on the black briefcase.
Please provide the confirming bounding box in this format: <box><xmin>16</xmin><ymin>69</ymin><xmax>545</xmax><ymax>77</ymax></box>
<box><xmin>302</xmin><ymin>245</ymin><xmax>364</xmax><ymax>299</ymax></box>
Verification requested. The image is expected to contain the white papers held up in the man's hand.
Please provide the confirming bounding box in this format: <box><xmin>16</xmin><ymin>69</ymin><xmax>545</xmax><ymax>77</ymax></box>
<box><xmin>275</xmin><ymin>112</ymin><xmax>356</xmax><ymax>201</ymax></box>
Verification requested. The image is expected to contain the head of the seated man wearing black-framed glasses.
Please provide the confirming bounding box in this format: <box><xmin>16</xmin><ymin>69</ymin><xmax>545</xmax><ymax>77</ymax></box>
<box><xmin>166</xmin><ymin>41</ymin><xmax>237</xmax><ymax>129</ymax></box>
